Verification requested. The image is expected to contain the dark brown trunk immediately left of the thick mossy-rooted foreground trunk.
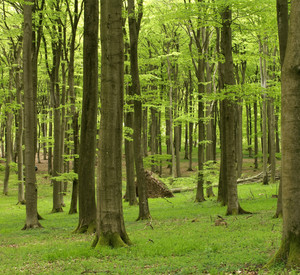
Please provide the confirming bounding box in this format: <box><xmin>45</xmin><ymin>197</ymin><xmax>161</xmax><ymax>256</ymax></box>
<box><xmin>75</xmin><ymin>0</ymin><xmax>96</xmax><ymax>233</ymax></box>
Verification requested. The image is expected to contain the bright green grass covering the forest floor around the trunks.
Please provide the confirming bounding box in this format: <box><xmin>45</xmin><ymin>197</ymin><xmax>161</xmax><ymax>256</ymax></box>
<box><xmin>0</xmin><ymin>174</ymin><xmax>296</xmax><ymax>274</ymax></box>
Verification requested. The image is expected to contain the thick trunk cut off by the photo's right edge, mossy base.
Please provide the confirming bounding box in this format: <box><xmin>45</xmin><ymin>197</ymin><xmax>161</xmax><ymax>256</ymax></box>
<box><xmin>270</xmin><ymin>1</ymin><xmax>300</xmax><ymax>268</ymax></box>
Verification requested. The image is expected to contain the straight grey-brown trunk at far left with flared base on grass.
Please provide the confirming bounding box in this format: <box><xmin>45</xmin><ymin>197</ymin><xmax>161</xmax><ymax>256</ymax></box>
<box><xmin>23</xmin><ymin>0</ymin><xmax>41</xmax><ymax>229</ymax></box>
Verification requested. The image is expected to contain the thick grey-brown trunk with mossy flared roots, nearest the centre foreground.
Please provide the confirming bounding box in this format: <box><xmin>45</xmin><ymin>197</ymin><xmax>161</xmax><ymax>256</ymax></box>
<box><xmin>93</xmin><ymin>0</ymin><xmax>130</xmax><ymax>247</ymax></box>
